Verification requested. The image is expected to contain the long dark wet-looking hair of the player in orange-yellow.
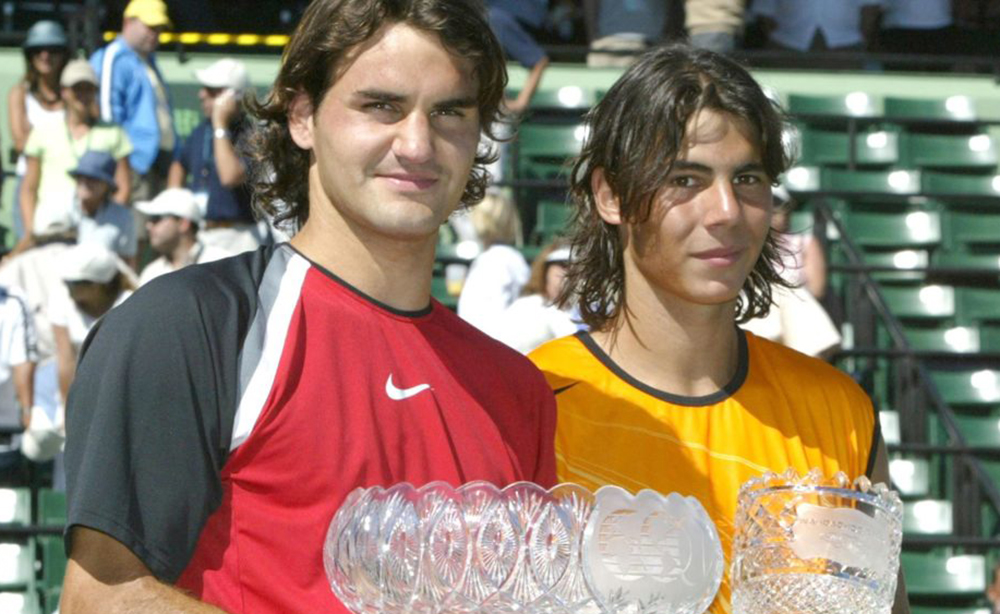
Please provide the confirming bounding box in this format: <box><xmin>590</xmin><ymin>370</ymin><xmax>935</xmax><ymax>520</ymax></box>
<box><xmin>559</xmin><ymin>44</ymin><xmax>790</xmax><ymax>330</ymax></box>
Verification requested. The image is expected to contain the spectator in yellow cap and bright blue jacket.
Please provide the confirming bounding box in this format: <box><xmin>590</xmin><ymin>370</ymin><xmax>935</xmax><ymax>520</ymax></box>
<box><xmin>90</xmin><ymin>0</ymin><xmax>177</xmax><ymax>203</ymax></box>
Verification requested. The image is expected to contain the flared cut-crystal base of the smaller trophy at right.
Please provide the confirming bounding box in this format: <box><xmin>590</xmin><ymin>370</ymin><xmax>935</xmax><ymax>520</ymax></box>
<box><xmin>733</xmin><ymin>573</ymin><xmax>892</xmax><ymax>614</ymax></box>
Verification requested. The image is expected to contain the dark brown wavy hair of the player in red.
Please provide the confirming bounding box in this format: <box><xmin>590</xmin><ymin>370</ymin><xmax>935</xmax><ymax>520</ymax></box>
<box><xmin>242</xmin><ymin>0</ymin><xmax>507</xmax><ymax>228</ymax></box>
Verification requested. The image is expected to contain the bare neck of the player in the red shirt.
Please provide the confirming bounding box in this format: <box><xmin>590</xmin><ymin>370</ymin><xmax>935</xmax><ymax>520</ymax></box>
<box><xmin>291</xmin><ymin>202</ymin><xmax>437</xmax><ymax>311</ymax></box>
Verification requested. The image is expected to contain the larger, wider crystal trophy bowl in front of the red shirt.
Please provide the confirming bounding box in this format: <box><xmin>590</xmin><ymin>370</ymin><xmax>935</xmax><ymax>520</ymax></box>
<box><xmin>323</xmin><ymin>482</ymin><xmax>723</xmax><ymax>614</ymax></box>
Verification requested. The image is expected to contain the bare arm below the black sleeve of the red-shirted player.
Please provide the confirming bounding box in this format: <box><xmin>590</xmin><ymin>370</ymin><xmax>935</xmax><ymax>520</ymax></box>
<box><xmin>59</xmin><ymin>526</ymin><xmax>224</xmax><ymax>614</ymax></box>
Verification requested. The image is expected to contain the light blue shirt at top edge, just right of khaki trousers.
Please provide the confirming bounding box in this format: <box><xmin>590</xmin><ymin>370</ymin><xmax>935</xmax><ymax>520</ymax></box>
<box><xmin>750</xmin><ymin>0</ymin><xmax>884</xmax><ymax>51</ymax></box>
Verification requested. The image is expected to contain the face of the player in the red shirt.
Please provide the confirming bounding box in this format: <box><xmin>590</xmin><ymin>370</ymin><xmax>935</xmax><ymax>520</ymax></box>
<box><xmin>292</xmin><ymin>24</ymin><xmax>480</xmax><ymax>245</ymax></box>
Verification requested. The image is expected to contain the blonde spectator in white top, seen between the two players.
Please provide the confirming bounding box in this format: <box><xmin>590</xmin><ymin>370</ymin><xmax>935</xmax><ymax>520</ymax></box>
<box><xmin>457</xmin><ymin>193</ymin><xmax>531</xmax><ymax>338</ymax></box>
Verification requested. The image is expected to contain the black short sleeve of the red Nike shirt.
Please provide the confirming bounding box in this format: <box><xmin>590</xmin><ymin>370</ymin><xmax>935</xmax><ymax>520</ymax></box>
<box><xmin>66</xmin><ymin>249</ymin><xmax>270</xmax><ymax>582</ymax></box>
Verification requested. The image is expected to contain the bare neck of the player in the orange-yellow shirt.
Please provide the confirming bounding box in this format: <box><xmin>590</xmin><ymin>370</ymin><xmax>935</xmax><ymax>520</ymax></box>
<box><xmin>593</xmin><ymin>272</ymin><xmax>739</xmax><ymax>397</ymax></box>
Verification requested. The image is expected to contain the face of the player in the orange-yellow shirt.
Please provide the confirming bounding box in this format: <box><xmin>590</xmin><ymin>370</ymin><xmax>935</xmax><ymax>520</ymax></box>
<box><xmin>608</xmin><ymin>110</ymin><xmax>772</xmax><ymax>312</ymax></box>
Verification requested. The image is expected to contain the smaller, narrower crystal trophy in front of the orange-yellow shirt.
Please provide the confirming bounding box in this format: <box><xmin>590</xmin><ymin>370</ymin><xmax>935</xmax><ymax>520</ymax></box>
<box><xmin>732</xmin><ymin>469</ymin><xmax>903</xmax><ymax>614</ymax></box>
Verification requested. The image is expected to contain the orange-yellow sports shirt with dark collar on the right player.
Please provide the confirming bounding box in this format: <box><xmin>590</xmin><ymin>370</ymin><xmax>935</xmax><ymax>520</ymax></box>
<box><xmin>530</xmin><ymin>331</ymin><xmax>878</xmax><ymax>614</ymax></box>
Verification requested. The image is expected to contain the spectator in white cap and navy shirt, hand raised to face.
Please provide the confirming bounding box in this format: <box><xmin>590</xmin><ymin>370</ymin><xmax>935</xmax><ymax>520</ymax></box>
<box><xmin>167</xmin><ymin>58</ymin><xmax>262</xmax><ymax>254</ymax></box>
